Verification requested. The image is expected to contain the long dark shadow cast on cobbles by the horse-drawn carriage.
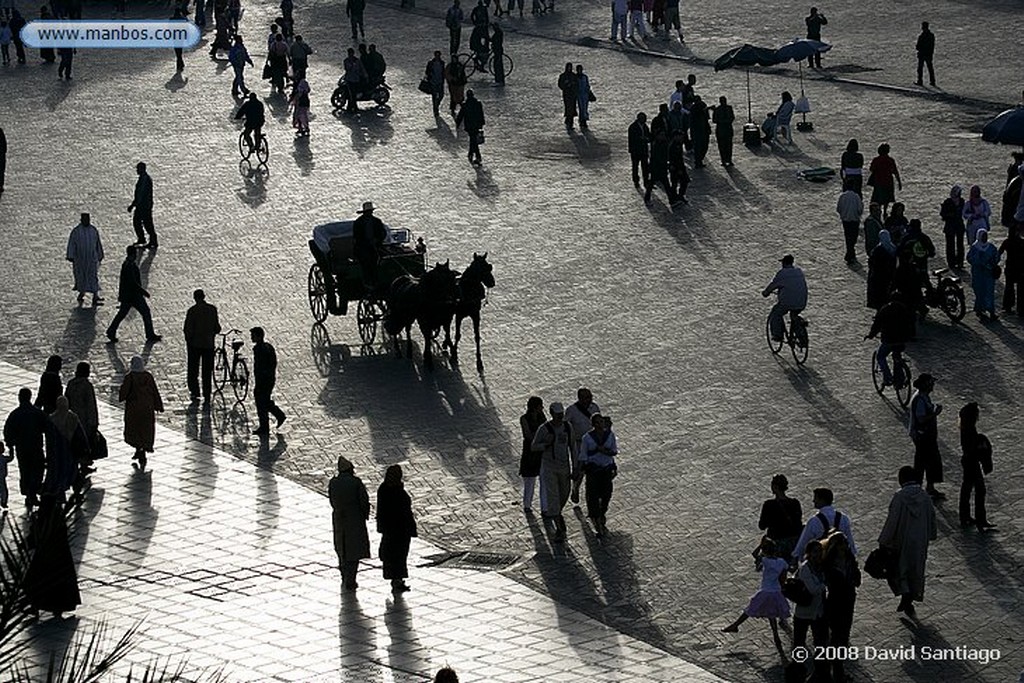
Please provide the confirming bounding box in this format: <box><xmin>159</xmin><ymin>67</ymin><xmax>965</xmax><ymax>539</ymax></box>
<box><xmin>310</xmin><ymin>325</ymin><xmax>509</xmax><ymax>495</ymax></box>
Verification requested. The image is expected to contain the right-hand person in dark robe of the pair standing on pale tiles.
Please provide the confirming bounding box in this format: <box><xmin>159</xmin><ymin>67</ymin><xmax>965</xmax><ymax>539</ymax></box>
<box><xmin>377</xmin><ymin>465</ymin><xmax>418</xmax><ymax>593</ymax></box>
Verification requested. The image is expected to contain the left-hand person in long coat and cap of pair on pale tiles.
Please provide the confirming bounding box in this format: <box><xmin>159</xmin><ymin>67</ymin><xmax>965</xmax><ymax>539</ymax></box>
<box><xmin>328</xmin><ymin>456</ymin><xmax>370</xmax><ymax>591</ymax></box>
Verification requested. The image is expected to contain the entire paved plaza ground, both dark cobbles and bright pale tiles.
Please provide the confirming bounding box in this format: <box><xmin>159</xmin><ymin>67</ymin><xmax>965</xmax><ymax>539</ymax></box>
<box><xmin>0</xmin><ymin>0</ymin><xmax>1024</xmax><ymax>683</ymax></box>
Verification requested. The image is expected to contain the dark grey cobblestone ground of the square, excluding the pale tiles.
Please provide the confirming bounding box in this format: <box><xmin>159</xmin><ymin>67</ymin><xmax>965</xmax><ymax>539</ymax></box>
<box><xmin>0</xmin><ymin>2</ymin><xmax>1024</xmax><ymax>682</ymax></box>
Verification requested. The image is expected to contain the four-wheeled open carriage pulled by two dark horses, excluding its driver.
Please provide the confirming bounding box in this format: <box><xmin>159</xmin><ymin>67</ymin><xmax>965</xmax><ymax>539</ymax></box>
<box><xmin>308</xmin><ymin>220</ymin><xmax>426</xmax><ymax>344</ymax></box>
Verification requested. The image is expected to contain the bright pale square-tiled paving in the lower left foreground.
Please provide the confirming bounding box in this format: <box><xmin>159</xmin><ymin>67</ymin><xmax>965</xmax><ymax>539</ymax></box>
<box><xmin>0</xmin><ymin>362</ymin><xmax>722</xmax><ymax>682</ymax></box>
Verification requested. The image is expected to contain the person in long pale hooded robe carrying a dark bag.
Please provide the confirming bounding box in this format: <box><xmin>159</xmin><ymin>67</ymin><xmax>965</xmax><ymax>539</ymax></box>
<box><xmin>879</xmin><ymin>465</ymin><xmax>937</xmax><ymax>618</ymax></box>
